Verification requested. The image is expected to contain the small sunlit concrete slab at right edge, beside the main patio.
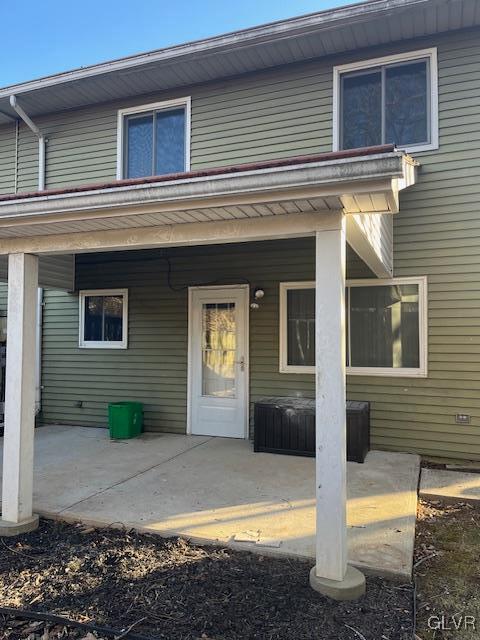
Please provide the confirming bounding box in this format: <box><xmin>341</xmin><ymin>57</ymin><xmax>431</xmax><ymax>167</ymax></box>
<box><xmin>419</xmin><ymin>469</ymin><xmax>480</xmax><ymax>502</ymax></box>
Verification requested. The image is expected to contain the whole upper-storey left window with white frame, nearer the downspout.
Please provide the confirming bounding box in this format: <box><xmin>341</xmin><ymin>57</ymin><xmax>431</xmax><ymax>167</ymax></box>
<box><xmin>117</xmin><ymin>98</ymin><xmax>190</xmax><ymax>179</ymax></box>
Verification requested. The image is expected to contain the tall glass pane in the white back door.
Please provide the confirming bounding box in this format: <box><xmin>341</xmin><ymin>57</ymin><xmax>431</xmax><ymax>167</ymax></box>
<box><xmin>202</xmin><ymin>302</ymin><xmax>237</xmax><ymax>398</ymax></box>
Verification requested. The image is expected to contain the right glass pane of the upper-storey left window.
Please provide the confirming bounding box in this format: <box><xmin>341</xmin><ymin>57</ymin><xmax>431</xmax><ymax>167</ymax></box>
<box><xmin>155</xmin><ymin>109</ymin><xmax>185</xmax><ymax>175</ymax></box>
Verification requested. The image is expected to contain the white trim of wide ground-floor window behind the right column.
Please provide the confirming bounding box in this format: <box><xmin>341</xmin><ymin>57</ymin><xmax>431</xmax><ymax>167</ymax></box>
<box><xmin>279</xmin><ymin>276</ymin><xmax>428</xmax><ymax>378</ymax></box>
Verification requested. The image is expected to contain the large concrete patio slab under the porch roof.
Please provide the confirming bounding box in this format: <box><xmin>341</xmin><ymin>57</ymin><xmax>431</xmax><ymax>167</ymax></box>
<box><xmin>0</xmin><ymin>426</ymin><xmax>419</xmax><ymax>580</ymax></box>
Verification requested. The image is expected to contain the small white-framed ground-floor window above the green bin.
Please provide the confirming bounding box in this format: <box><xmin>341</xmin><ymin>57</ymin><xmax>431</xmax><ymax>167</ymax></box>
<box><xmin>79</xmin><ymin>289</ymin><xmax>128</xmax><ymax>349</ymax></box>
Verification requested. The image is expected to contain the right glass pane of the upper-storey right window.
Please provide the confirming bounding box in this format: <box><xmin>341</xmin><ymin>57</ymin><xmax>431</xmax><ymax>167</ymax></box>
<box><xmin>385</xmin><ymin>60</ymin><xmax>428</xmax><ymax>146</ymax></box>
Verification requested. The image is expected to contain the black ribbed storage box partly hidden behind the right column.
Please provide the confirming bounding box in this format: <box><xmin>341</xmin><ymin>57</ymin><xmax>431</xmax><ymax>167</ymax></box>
<box><xmin>254</xmin><ymin>398</ymin><xmax>370</xmax><ymax>462</ymax></box>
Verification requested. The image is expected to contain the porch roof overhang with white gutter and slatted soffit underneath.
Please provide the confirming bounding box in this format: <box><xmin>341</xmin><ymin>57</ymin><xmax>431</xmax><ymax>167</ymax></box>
<box><xmin>0</xmin><ymin>145</ymin><xmax>415</xmax><ymax>242</ymax></box>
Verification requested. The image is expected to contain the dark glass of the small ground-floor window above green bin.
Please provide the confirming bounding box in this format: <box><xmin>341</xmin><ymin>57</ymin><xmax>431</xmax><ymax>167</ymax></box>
<box><xmin>84</xmin><ymin>296</ymin><xmax>123</xmax><ymax>342</ymax></box>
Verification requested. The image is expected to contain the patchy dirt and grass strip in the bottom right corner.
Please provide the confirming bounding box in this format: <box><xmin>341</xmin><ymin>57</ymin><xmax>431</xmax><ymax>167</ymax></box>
<box><xmin>415</xmin><ymin>501</ymin><xmax>480</xmax><ymax>640</ymax></box>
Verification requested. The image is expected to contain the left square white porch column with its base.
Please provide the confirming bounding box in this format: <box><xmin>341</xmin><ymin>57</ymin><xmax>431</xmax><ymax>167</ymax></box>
<box><xmin>0</xmin><ymin>253</ymin><xmax>38</xmax><ymax>536</ymax></box>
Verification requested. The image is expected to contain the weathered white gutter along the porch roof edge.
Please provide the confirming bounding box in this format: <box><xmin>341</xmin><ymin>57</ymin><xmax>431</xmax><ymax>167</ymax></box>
<box><xmin>0</xmin><ymin>151</ymin><xmax>412</xmax><ymax>223</ymax></box>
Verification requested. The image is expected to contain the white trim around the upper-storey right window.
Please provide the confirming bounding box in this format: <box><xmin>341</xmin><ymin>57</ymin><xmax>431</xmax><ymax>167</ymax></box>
<box><xmin>333</xmin><ymin>47</ymin><xmax>438</xmax><ymax>153</ymax></box>
